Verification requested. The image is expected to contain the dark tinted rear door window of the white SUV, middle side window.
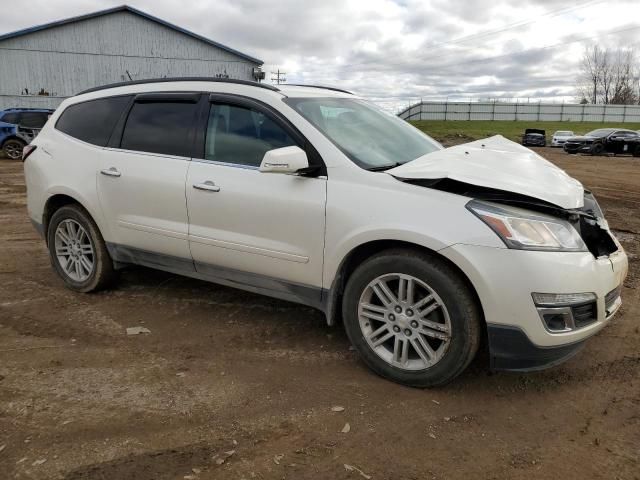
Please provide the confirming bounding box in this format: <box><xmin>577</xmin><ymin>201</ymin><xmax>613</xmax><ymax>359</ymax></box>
<box><xmin>120</xmin><ymin>102</ymin><xmax>197</xmax><ymax>157</ymax></box>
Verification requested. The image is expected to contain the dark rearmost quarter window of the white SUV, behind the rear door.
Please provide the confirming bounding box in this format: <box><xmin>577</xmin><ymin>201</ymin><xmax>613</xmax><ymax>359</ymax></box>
<box><xmin>56</xmin><ymin>97</ymin><xmax>131</xmax><ymax>147</ymax></box>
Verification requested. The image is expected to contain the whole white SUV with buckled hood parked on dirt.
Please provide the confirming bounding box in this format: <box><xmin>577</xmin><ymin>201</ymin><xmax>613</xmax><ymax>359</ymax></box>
<box><xmin>23</xmin><ymin>79</ymin><xmax>627</xmax><ymax>387</ymax></box>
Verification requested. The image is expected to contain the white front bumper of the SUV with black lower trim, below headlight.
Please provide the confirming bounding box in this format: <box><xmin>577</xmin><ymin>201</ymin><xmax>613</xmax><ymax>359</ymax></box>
<box><xmin>440</xmin><ymin>244</ymin><xmax>628</xmax><ymax>369</ymax></box>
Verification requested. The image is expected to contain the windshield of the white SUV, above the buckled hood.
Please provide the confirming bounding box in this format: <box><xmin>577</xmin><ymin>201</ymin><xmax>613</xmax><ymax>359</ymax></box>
<box><xmin>284</xmin><ymin>98</ymin><xmax>442</xmax><ymax>170</ymax></box>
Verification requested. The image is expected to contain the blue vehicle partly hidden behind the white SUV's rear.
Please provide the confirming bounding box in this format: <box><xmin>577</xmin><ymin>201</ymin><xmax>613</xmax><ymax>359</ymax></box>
<box><xmin>0</xmin><ymin>108</ymin><xmax>53</xmax><ymax>160</ymax></box>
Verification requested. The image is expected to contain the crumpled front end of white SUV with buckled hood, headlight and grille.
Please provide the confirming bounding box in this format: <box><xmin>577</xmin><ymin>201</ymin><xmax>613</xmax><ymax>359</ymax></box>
<box><xmin>387</xmin><ymin>135</ymin><xmax>619</xmax><ymax>258</ymax></box>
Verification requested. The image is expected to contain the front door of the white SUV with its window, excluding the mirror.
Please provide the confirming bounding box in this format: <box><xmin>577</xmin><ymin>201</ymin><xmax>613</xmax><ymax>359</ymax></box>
<box><xmin>186</xmin><ymin>95</ymin><xmax>327</xmax><ymax>303</ymax></box>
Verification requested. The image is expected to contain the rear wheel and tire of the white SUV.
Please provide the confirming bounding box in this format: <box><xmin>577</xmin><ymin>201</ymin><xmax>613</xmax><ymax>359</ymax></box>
<box><xmin>47</xmin><ymin>205</ymin><xmax>115</xmax><ymax>293</ymax></box>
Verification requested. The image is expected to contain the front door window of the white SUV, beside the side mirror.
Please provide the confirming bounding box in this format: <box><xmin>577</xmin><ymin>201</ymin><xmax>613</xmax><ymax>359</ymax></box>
<box><xmin>205</xmin><ymin>104</ymin><xmax>296</xmax><ymax>167</ymax></box>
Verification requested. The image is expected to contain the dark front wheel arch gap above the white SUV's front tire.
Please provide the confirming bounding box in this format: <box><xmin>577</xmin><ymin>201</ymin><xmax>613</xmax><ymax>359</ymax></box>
<box><xmin>325</xmin><ymin>239</ymin><xmax>486</xmax><ymax>328</ymax></box>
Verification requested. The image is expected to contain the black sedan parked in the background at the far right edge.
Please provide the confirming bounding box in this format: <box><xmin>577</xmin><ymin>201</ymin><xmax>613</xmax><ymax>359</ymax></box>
<box><xmin>564</xmin><ymin>128</ymin><xmax>640</xmax><ymax>157</ymax></box>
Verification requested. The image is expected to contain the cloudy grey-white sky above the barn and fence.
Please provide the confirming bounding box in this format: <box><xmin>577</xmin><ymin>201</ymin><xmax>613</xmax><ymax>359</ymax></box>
<box><xmin>0</xmin><ymin>0</ymin><xmax>640</xmax><ymax>110</ymax></box>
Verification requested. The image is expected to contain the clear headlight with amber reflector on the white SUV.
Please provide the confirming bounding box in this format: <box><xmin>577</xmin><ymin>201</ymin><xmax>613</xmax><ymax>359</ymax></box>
<box><xmin>467</xmin><ymin>200</ymin><xmax>587</xmax><ymax>252</ymax></box>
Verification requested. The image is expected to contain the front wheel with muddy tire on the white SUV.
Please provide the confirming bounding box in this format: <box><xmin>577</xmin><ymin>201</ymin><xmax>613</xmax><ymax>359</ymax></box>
<box><xmin>342</xmin><ymin>250</ymin><xmax>482</xmax><ymax>388</ymax></box>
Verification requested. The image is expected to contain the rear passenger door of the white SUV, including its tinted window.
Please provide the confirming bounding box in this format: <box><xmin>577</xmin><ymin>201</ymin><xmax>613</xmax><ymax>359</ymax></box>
<box><xmin>97</xmin><ymin>93</ymin><xmax>201</xmax><ymax>270</ymax></box>
